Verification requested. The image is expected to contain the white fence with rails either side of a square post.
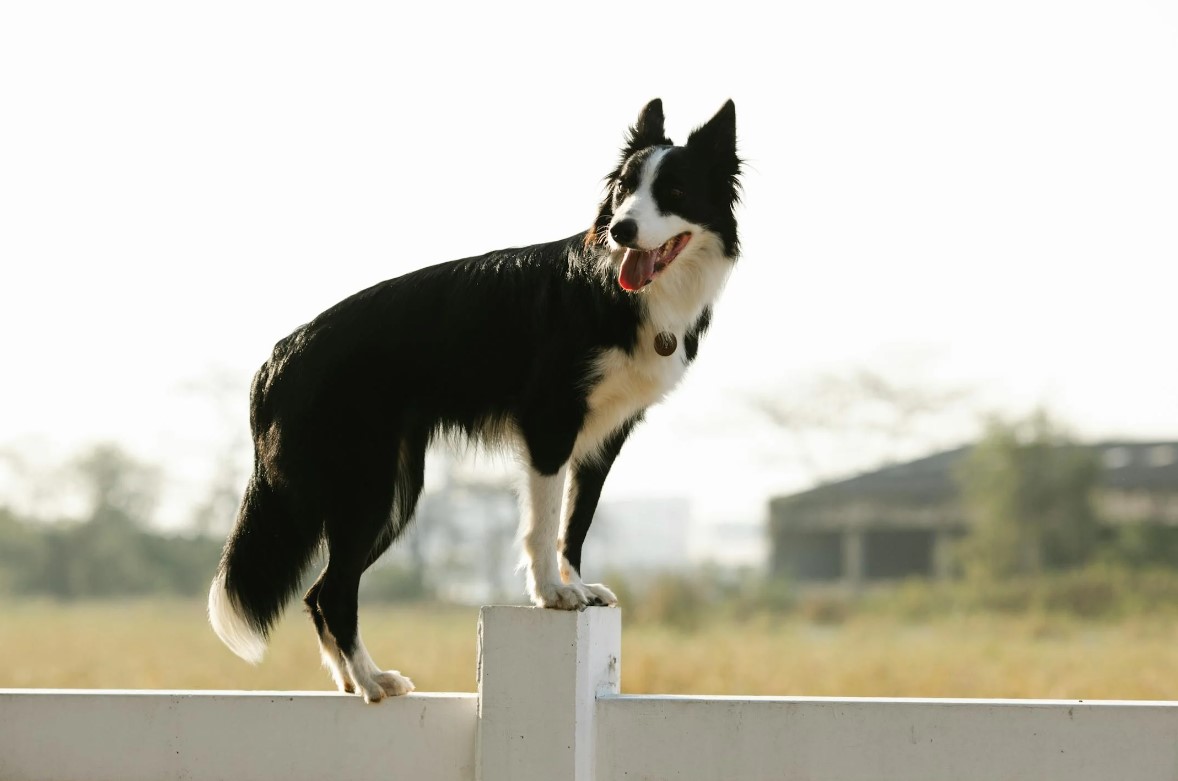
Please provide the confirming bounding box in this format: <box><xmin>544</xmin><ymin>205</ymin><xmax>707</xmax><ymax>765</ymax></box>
<box><xmin>0</xmin><ymin>607</ymin><xmax>1178</xmax><ymax>781</ymax></box>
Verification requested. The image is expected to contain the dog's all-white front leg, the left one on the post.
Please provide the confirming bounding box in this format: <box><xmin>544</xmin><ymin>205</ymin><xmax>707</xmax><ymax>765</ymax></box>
<box><xmin>523</xmin><ymin>465</ymin><xmax>590</xmax><ymax>610</ymax></box>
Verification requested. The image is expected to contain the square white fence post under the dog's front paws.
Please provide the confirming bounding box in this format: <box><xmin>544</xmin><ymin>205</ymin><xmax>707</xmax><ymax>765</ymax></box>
<box><xmin>477</xmin><ymin>607</ymin><xmax>622</xmax><ymax>781</ymax></box>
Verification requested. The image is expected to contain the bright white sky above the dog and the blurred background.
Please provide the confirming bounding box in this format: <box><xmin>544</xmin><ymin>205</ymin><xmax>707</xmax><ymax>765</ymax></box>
<box><xmin>0</xmin><ymin>0</ymin><xmax>1178</xmax><ymax>532</ymax></box>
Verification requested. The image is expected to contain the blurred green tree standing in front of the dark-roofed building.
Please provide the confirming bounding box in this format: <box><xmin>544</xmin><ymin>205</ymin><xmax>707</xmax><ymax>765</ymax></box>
<box><xmin>955</xmin><ymin>411</ymin><xmax>1099</xmax><ymax>577</ymax></box>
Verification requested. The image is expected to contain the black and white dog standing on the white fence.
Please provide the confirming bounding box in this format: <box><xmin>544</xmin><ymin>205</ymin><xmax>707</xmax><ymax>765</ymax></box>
<box><xmin>209</xmin><ymin>100</ymin><xmax>741</xmax><ymax>702</ymax></box>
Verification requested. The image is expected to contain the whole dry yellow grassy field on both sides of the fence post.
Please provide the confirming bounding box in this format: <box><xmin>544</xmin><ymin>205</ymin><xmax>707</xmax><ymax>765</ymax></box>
<box><xmin>0</xmin><ymin>601</ymin><xmax>1178</xmax><ymax>700</ymax></box>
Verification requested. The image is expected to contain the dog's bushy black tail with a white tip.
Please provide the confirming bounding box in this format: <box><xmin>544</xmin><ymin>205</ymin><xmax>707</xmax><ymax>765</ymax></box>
<box><xmin>209</xmin><ymin>471</ymin><xmax>323</xmax><ymax>664</ymax></box>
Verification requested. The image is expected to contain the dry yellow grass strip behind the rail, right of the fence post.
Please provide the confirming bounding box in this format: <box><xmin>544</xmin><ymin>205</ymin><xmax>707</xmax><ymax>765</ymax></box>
<box><xmin>623</xmin><ymin>616</ymin><xmax>1178</xmax><ymax>700</ymax></box>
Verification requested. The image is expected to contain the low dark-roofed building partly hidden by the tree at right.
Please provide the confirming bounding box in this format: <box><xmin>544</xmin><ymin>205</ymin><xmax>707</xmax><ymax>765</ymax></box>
<box><xmin>769</xmin><ymin>442</ymin><xmax>1178</xmax><ymax>588</ymax></box>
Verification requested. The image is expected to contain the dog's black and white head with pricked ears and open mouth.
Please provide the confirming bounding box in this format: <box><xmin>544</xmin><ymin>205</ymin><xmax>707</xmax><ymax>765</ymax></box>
<box><xmin>587</xmin><ymin>99</ymin><xmax>741</xmax><ymax>291</ymax></box>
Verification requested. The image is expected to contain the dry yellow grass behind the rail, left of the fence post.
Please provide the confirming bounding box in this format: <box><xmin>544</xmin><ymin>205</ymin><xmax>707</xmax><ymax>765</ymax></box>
<box><xmin>0</xmin><ymin>600</ymin><xmax>478</xmax><ymax>691</ymax></box>
